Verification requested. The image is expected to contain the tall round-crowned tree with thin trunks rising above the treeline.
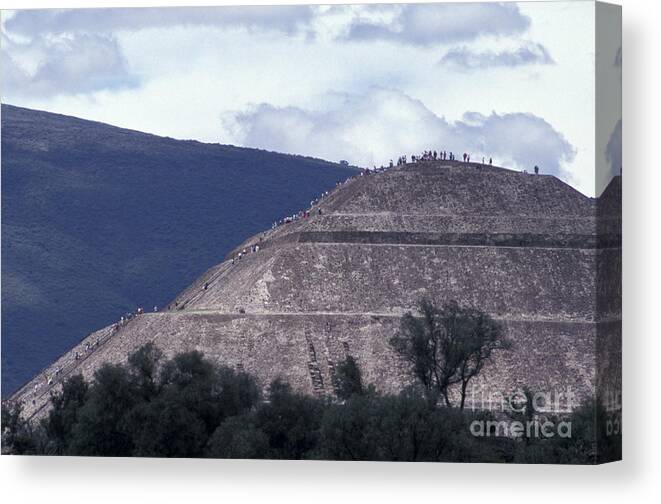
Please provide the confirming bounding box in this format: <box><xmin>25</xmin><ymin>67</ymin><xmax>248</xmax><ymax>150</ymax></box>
<box><xmin>390</xmin><ymin>300</ymin><xmax>511</xmax><ymax>409</ymax></box>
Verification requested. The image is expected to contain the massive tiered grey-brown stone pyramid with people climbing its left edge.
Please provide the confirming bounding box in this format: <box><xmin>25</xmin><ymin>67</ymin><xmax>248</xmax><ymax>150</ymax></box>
<box><xmin>12</xmin><ymin>161</ymin><xmax>621</xmax><ymax>416</ymax></box>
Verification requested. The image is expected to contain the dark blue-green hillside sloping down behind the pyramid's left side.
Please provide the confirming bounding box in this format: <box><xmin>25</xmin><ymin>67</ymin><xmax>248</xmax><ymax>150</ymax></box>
<box><xmin>2</xmin><ymin>104</ymin><xmax>355</xmax><ymax>397</ymax></box>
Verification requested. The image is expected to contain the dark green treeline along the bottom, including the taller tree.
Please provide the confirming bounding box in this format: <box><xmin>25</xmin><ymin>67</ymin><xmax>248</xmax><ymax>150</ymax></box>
<box><xmin>2</xmin><ymin>304</ymin><xmax>620</xmax><ymax>464</ymax></box>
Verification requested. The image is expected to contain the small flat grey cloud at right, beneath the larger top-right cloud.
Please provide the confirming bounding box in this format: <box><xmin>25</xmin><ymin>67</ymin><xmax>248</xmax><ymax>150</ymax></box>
<box><xmin>439</xmin><ymin>42</ymin><xmax>554</xmax><ymax>70</ymax></box>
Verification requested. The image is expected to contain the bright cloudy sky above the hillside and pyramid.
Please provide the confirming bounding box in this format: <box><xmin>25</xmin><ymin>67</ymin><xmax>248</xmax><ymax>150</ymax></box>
<box><xmin>0</xmin><ymin>1</ymin><xmax>621</xmax><ymax>196</ymax></box>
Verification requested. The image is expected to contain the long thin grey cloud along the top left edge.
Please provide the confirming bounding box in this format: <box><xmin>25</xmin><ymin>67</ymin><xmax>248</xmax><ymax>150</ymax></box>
<box><xmin>4</xmin><ymin>5</ymin><xmax>313</xmax><ymax>37</ymax></box>
